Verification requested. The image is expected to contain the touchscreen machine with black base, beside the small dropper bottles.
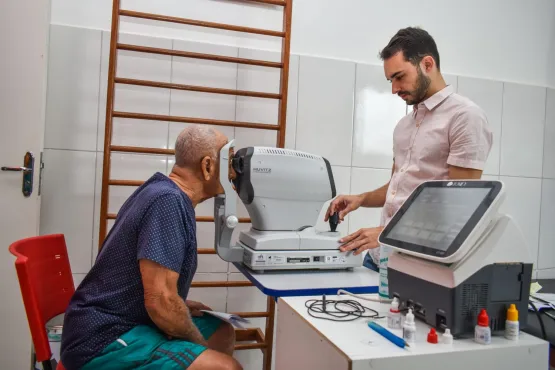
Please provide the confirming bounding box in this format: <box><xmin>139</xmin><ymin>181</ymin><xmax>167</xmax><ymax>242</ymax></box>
<box><xmin>379</xmin><ymin>181</ymin><xmax>533</xmax><ymax>337</ymax></box>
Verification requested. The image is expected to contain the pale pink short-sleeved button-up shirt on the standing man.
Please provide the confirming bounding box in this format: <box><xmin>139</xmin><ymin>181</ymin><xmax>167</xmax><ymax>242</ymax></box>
<box><xmin>373</xmin><ymin>86</ymin><xmax>493</xmax><ymax>260</ymax></box>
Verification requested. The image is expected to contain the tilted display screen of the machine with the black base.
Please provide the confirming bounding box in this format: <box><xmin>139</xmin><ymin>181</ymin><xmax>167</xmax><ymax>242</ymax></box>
<box><xmin>380</xmin><ymin>181</ymin><xmax>501</xmax><ymax>257</ymax></box>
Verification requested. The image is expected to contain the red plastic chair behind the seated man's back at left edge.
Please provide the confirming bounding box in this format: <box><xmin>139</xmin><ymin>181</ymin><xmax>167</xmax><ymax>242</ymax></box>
<box><xmin>9</xmin><ymin>234</ymin><xmax>75</xmax><ymax>370</ymax></box>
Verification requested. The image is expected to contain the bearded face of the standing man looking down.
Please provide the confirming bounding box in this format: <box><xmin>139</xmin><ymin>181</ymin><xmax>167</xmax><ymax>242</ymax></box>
<box><xmin>384</xmin><ymin>52</ymin><xmax>431</xmax><ymax>105</ymax></box>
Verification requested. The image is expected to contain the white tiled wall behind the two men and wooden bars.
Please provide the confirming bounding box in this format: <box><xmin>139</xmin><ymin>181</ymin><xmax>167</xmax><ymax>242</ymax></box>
<box><xmin>41</xmin><ymin>25</ymin><xmax>555</xmax><ymax>369</ymax></box>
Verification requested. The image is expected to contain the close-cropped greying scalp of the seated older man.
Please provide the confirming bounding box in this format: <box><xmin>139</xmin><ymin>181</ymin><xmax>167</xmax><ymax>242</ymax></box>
<box><xmin>175</xmin><ymin>125</ymin><xmax>227</xmax><ymax>170</ymax></box>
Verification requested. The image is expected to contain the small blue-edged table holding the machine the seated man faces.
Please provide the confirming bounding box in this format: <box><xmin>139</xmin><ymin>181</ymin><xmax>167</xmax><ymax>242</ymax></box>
<box><xmin>234</xmin><ymin>263</ymin><xmax>379</xmax><ymax>298</ymax></box>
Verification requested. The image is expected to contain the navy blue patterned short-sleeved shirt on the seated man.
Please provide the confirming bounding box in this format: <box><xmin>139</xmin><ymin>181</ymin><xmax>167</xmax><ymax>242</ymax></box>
<box><xmin>61</xmin><ymin>173</ymin><xmax>197</xmax><ymax>370</ymax></box>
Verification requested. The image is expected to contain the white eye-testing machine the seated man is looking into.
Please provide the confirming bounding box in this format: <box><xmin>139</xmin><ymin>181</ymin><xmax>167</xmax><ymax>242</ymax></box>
<box><xmin>214</xmin><ymin>140</ymin><xmax>362</xmax><ymax>271</ymax></box>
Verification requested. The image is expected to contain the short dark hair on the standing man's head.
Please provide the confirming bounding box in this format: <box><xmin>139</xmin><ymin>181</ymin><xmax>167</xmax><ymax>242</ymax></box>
<box><xmin>380</xmin><ymin>27</ymin><xmax>439</xmax><ymax>70</ymax></box>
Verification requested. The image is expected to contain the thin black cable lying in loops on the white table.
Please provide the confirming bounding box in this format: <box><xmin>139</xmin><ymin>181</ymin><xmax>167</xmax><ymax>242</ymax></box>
<box><xmin>305</xmin><ymin>296</ymin><xmax>383</xmax><ymax>322</ymax></box>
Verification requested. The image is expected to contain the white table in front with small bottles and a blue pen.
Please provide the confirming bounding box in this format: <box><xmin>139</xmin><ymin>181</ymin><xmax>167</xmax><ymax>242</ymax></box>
<box><xmin>275</xmin><ymin>294</ymin><xmax>549</xmax><ymax>370</ymax></box>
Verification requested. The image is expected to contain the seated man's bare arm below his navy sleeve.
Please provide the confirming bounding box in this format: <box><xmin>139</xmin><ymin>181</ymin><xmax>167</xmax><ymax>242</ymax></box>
<box><xmin>139</xmin><ymin>259</ymin><xmax>206</xmax><ymax>346</ymax></box>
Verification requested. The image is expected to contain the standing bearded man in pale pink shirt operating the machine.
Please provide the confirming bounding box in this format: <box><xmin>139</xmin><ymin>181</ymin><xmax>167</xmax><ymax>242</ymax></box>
<box><xmin>325</xmin><ymin>27</ymin><xmax>492</xmax><ymax>270</ymax></box>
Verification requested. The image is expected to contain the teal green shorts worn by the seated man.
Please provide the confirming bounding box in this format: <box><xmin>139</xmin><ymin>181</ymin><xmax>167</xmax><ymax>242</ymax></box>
<box><xmin>82</xmin><ymin>315</ymin><xmax>222</xmax><ymax>370</ymax></box>
